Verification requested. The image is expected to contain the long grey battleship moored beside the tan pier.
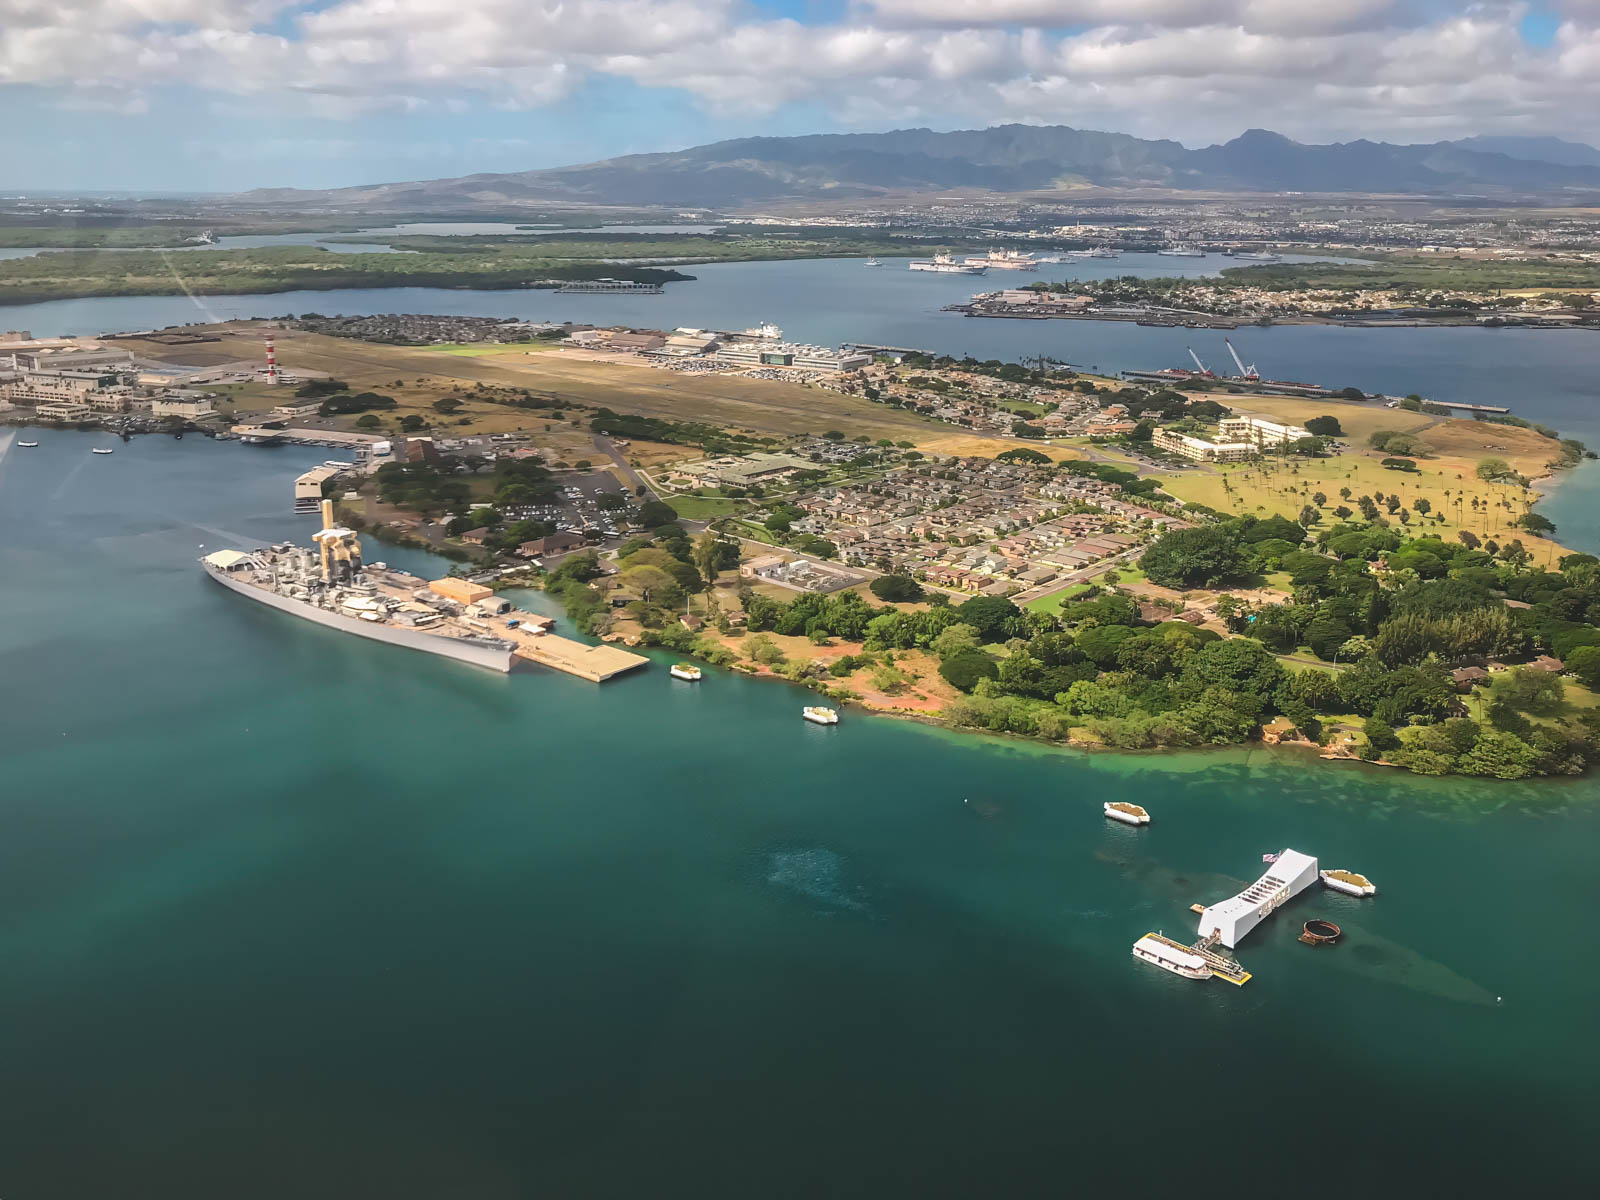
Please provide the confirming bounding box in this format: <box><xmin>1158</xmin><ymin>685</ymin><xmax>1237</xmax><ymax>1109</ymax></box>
<box><xmin>200</xmin><ymin>501</ymin><xmax>515</xmax><ymax>672</ymax></box>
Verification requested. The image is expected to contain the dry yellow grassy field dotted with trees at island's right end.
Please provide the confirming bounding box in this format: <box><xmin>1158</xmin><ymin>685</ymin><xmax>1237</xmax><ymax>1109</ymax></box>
<box><xmin>1162</xmin><ymin>414</ymin><xmax>1560</xmax><ymax>563</ymax></box>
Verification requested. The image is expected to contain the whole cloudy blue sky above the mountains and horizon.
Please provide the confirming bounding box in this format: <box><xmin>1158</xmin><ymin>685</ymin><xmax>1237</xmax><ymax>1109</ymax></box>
<box><xmin>0</xmin><ymin>0</ymin><xmax>1600</xmax><ymax>190</ymax></box>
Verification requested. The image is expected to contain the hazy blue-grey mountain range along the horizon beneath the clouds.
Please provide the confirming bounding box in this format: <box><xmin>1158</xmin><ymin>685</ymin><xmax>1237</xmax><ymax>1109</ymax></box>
<box><xmin>234</xmin><ymin>125</ymin><xmax>1600</xmax><ymax>213</ymax></box>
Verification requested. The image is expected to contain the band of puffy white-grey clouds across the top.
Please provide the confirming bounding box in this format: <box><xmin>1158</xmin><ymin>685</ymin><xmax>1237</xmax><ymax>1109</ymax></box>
<box><xmin>0</xmin><ymin>0</ymin><xmax>1600</xmax><ymax>142</ymax></box>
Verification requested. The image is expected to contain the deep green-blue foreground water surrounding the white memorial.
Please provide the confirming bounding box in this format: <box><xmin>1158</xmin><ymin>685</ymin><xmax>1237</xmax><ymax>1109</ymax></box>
<box><xmin>0</xmin><ymin>432</ymin><xmax>1600</xmax><ymax>1197</ymax></box>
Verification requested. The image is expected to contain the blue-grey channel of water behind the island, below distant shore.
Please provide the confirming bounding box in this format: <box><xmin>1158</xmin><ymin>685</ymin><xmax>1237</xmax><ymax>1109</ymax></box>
<box><xmin>0</xmin><ymin>254</ymin><xmax>1600</xmax><ymax>432</ymax></box>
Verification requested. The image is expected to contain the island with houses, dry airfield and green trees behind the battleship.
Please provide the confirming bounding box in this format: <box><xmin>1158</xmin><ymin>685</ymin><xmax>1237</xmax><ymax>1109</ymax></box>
<box><xmin>18</xmin><ymin>318</ymin><xmax>1600</xmax><ymax>778</ymax></box>
